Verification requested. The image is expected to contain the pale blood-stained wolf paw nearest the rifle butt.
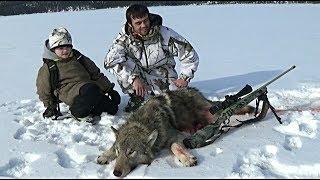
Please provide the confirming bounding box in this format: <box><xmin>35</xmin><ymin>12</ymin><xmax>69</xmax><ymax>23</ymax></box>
<box><xmin>171</xmin><ymin>142</ymin><xmax>197</xmax><ymax>167</ymax></box>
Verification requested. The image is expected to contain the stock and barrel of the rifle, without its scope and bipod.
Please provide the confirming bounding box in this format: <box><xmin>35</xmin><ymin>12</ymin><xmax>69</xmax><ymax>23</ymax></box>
<box><xmin>183</xmin><ymin>65</ymin><xmax>296</xmax><ymax>149</ymax></box>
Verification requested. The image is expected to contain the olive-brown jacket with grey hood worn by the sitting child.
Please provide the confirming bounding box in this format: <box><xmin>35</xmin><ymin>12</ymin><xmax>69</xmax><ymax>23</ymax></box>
<box><xmin>36</xmin><ymin>40</ymin><xmax>115</xmax><ymax>107</ymax></box>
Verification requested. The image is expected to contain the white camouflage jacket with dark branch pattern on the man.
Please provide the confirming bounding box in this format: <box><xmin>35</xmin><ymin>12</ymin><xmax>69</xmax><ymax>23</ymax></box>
<box><xmin>104</xmin><ymin>14</ymin><xmax>199</xmax><ymax>94</ymax></box>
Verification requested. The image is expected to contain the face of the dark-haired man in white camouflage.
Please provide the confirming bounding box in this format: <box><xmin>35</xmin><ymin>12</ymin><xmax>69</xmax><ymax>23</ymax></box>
<box><xmin>131</xmin><ymin>14</ymin><xmax>150</xmax><ymax>36</ymax></box>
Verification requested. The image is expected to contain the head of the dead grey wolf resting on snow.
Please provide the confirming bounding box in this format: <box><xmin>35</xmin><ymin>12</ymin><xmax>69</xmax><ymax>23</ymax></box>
<box><xmin>111</xmin><ymin>127</ymin><xmax>158</xmax><ymax>177</ymax></box>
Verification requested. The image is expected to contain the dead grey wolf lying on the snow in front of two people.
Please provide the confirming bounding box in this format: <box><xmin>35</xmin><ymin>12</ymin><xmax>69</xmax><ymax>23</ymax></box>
<box><xmin>97</xmin><ymin>87</ymin><xmax>254</xmax><ymax>177</ymax></box>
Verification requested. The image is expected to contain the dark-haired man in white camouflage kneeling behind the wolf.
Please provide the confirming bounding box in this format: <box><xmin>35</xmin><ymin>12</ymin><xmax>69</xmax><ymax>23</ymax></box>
<box><xmin>104</xmin><ymin>4</ymin><xmax>199</xmax><ymax>112</ymax></box>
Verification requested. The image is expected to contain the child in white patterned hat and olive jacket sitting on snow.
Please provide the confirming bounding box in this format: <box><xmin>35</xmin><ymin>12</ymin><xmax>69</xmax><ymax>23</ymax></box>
<box><xmin>36</xmin><ymin>27</ymin><xmax>120</xmax><ymax>121</ymax></box>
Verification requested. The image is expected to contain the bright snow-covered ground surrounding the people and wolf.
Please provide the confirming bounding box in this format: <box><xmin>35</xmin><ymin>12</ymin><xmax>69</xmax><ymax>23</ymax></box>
<box><xmin>0</xmin><ymin>4</ymin><xmax>320</xmax><ymax>178</ymax></box>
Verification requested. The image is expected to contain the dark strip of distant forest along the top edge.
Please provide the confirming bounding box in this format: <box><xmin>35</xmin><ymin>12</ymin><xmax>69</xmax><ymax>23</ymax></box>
<box><xmin>0</xmin><ymin>1</ymin><xmax>320</xmax><ymax>16</ymax></box>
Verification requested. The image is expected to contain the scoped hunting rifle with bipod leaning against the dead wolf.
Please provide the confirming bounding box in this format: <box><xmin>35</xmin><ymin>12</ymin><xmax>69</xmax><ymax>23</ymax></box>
<box><xmin>183</xmin><ymin>65</ymin><xmax>296</xmax><ymax>149</ymax></box>
